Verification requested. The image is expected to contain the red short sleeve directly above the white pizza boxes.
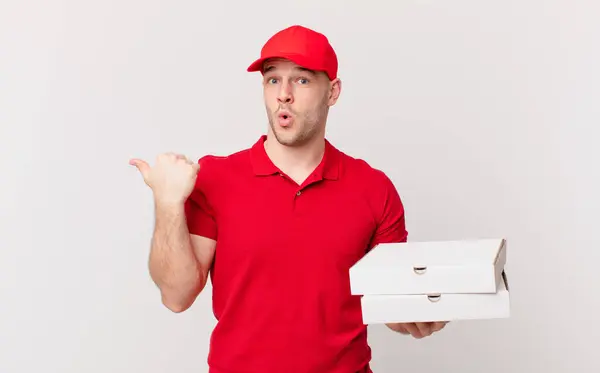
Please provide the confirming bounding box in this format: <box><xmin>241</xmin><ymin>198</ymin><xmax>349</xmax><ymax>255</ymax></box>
<box><xmin>369</xmin><ymin>173</ymin><xmax>408</xmax><ymax>249</ymax></box>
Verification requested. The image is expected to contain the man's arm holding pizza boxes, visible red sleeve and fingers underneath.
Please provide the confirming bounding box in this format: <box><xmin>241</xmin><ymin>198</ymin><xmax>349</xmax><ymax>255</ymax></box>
<box><xmin>369</xmin><ymin>172</ymin><xmax>447</xmax><ymax>339</ymax></box>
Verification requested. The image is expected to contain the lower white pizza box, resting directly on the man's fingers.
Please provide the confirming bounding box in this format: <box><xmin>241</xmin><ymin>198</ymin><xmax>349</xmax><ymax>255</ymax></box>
<box><xmin>361</xmin><ymin>272</ymin><xmax>510</xmax><ymax>325</ymax></box>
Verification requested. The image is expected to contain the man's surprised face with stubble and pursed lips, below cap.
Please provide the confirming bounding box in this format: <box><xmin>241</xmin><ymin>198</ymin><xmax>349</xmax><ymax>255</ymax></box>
<box><xmin>263</xmin><ymin>59</ymin><xmax>341</xmax><ymax>147</ymax></box>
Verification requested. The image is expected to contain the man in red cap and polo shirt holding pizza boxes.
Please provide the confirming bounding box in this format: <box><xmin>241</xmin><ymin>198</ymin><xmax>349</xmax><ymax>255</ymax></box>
<box><xmin>131</xmin><ymin>26</ymin><xmax>444</xmax><ymax>373</ymax></box>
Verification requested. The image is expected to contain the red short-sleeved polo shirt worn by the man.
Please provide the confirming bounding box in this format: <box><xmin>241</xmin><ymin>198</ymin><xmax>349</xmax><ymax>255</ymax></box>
<box><xmin>187</xmin><ymin>136</ymin><xmax>407</xmax><ymax>373</ymax></box>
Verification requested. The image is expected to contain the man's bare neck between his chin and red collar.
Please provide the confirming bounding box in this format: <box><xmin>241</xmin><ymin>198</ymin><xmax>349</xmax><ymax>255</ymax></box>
<box><xmin>265</xmin><ymin>133</ymin><xmax>325</xmax><ymax>179</ymax></box>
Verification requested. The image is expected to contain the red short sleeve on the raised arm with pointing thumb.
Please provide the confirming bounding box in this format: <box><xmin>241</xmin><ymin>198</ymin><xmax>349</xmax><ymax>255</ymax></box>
<box><xmin>185</xmin><ymin>159</ymin><xmax>217</xmax><ymax>240</ymax></box>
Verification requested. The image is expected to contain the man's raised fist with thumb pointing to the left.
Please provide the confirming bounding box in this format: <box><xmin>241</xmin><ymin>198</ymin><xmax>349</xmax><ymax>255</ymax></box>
<box><xmin>129</xmin><ymin>153</ymin><xmax>200</xmax><ymax>205</ymax></box>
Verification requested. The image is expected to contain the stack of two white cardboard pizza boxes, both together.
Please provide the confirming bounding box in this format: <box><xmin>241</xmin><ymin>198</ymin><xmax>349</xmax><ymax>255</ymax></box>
<box><xmin>350</xmin><ymin>238</ymin><xmax>510</xmax><ymax>324</ymax></box>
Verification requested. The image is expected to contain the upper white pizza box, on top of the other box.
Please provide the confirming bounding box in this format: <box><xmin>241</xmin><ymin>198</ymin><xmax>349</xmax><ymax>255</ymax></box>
<box><xmin>350</xmin><ymin>238</ymin><xmax>506</xmax><ymax>295</ymax></box>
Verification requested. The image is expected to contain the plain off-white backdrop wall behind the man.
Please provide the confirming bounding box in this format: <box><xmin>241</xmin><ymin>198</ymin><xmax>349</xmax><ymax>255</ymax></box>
<box><xmin>0</xmin><ymin>0</ymin><xmax>600</xmax><ymax>373</ymax></box>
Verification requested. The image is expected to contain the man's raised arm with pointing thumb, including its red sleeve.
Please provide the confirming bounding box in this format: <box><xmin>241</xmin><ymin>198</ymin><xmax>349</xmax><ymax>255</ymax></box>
<box><xmin>129</xmin><ymin>153</ymin><xmax>217</xmax><ymax>312</ymax></box>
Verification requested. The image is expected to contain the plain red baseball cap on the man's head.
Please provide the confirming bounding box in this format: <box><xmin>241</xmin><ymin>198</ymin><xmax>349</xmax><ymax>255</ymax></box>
<box><xmin>248</xmin><ymin>25</ymin><xmax>338</xmax><ymax>80</ymax></box>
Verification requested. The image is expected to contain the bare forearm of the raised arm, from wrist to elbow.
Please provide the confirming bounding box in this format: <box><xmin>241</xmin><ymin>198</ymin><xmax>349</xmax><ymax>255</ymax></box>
<box><xmin>149</xmin><ymin>203</ymin><xmax>206</xmax><ymax>312</ymax></box>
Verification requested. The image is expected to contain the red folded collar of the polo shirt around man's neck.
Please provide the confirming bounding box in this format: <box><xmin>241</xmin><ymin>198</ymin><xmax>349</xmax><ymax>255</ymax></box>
<box><xmin>250</xmin><ymin>135</ymin><xmax>340</xmax><ymax>180</ymax></box>
